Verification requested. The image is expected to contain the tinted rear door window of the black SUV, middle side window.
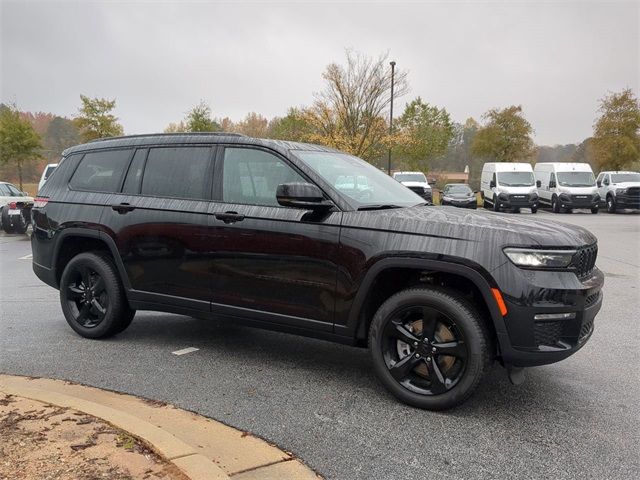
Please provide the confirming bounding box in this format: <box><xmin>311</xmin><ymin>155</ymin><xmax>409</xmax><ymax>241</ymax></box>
<box><xmin>140</xmin><ymin>147</ymin><xmax>211</xmax><ymax>200</ymax></box>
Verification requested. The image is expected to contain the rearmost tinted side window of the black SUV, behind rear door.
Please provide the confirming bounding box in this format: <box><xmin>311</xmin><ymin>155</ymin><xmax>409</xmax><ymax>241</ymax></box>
<box><xmin>69</xmin><ymin>150</ymin><xmax>131</xmax><ymax>192</ymax></box>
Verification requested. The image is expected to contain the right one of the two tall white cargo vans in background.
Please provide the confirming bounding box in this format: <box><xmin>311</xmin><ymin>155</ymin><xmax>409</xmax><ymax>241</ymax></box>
<box><xmin>534</xmin><ymin>162</ymin><xmax>600</xmax><ymax>213</ymax></box>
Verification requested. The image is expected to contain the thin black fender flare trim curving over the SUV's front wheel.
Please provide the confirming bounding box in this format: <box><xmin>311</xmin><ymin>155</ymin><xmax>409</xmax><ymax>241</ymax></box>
<box><xmin>336</xmin><ymin>257</ymin><xmax>507</xmax><ymax>342</ymax></box>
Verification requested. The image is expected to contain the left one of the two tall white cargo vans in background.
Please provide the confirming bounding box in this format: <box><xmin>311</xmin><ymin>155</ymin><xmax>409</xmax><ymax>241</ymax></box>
<box><xmin>480</xmin><ymin>162</ymin><xmax>538</xmax><ymax>213</ymax></box>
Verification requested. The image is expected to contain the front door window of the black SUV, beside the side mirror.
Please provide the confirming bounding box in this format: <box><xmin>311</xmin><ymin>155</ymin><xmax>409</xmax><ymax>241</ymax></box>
<box><xmin>222</xmin><ymin>148</ymin><xmax>306</xmax><ymax>206</ymax></box>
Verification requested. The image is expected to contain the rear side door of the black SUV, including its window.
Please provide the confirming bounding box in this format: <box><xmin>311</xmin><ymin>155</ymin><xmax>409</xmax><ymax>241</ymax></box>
<box><xmin>103</xmin><ymin>145</ymin><xmax>214</xmax><ymax>311</ymax></box>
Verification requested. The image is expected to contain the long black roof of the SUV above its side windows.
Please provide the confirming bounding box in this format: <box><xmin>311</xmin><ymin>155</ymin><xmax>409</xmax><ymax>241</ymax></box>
<box><xmin>62</xmin><ymin>132</ymin><xmax>336</xmax><ymax>156</ymax></box>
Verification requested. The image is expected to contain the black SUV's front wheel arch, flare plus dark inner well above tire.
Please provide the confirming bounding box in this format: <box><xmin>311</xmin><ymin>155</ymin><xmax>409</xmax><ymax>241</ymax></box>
<box><xmin>336</xmin><ymin>257</ymin><xmax>506</xmax><ymax>345</ymax></box>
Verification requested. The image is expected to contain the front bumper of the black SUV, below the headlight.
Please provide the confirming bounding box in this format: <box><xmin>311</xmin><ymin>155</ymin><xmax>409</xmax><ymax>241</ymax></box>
<box><xmin>498</xmin><ymin>267</ymin><xmax>604</xmax><ymax>367</ymax></box>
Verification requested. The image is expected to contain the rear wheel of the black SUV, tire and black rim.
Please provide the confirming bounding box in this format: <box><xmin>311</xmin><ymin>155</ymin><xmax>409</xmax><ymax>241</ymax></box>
<box><xmin>60</xmin><ymin>252</ymin><xmax>135</xmax><ymax>339</ymax></box>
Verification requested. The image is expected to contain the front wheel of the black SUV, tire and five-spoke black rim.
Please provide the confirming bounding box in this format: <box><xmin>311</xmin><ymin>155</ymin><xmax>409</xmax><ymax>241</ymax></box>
<box><xmin>369</xmin><ymin>288</ymin><xmax>492</xmax><ymax>410</ymax></box>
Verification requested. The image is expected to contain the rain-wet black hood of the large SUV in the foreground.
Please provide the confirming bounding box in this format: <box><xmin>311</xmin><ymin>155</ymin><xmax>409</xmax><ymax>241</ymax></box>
<box><xmin>344</xmin><ymin>206</ymin><xmax>597</xmax><ymax>247</ymax></box>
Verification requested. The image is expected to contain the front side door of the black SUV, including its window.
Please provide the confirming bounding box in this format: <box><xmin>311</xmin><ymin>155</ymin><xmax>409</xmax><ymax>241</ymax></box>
<box><xmin>209</xmin><ymin>146</ymin><xmax>342</xmax><ymax>330</ymax></box>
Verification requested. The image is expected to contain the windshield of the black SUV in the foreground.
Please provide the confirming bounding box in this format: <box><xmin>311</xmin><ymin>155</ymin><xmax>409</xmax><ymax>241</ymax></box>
<box><xmin>292</xmin><ymin>150</ymin><xmax>424</xmax><ymax>207</ymax></box>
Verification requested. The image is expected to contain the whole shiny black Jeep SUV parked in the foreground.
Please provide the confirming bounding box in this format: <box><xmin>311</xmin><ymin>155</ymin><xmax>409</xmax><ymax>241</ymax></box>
<box><xmin>32</xmin><ymin>134</ymin><xmax>603</xmax><ymax>409</ymax></box>
